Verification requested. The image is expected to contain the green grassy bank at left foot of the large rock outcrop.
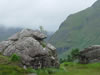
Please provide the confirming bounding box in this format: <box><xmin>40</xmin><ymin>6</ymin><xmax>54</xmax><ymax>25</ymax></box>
<box><xmin>0</xmin><ymin>54</ymin><xmax>30</xmax><ymax>75</ymax></box>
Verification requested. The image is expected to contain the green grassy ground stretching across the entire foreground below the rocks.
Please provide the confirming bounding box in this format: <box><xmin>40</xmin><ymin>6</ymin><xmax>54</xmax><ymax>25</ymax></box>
<box><xmin>0</xmin><ymin>55</ymin><xmax>100</xmax><ymax>75</ymax></box>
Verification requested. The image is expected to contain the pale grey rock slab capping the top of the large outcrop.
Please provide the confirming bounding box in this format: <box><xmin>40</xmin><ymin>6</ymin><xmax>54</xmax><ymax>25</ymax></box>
<box><xmin>9</xmin><ymin>29</ymin><xmax>47</xmax><ymax>41</ymax></box>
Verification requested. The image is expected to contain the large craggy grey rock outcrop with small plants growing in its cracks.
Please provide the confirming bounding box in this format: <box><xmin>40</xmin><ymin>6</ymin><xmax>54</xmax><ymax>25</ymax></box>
<box><xmin>0</xmin><ymin>29</ymin><xmax>59</xmax><ymax>69</ymax></box>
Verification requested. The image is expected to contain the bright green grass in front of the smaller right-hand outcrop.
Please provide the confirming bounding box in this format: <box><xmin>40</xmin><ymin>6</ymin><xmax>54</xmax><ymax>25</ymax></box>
<box><xmin>62</xmin><ymin>63</ymin><xmax>100</xmax><ymax>75</ymax></box>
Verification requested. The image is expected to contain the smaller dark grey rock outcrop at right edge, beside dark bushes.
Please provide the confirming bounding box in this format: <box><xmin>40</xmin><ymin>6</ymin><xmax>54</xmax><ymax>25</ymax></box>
<box><xmin>79</xmin><ymin>45</ymin><xmax>100</xmax><ymax>64</ymax></box>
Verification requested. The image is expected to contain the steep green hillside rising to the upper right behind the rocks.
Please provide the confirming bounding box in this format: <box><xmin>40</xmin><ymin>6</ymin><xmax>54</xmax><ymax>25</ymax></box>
<box><xmin>50</xmin><ymin>0</ymin><xmax>100</xmax><ymax>54</ymax></box>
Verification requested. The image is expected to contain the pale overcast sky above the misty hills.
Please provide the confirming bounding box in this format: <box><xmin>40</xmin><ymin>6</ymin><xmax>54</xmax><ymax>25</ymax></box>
<box><xmin>0</xmin><ymin>0</ymin><xmax>96</xmax><ymax>31</ymax></box>
